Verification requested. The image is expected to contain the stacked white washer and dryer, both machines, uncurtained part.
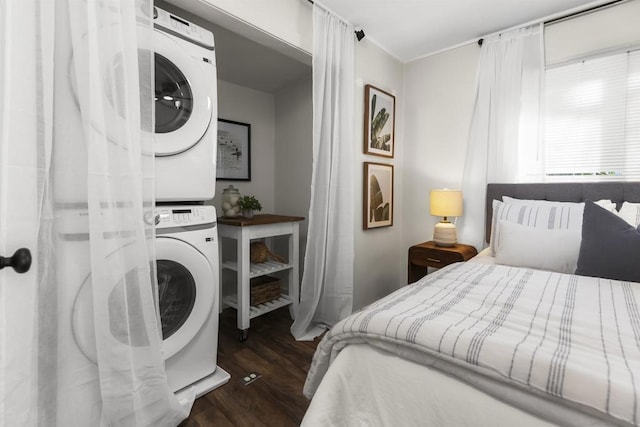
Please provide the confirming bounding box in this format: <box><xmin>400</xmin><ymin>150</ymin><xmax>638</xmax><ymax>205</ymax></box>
<box><xmin>154</xmin><ymin>8</ymin><xmax>229</xmax><ymax>402</ymax></box>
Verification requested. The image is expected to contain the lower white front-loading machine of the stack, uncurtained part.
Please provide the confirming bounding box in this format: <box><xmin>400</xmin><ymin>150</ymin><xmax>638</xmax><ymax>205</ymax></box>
<box><xmin>156</xmin><ymin>205</ymin><xmax>229</xmax><ymax>396</ymax></box>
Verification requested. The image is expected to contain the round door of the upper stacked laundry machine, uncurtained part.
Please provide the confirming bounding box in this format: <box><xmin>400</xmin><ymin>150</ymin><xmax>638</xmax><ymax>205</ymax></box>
<box><xmin>153</xmin><ymin>30</ymin><xmax>216</xmax><ymax>156</ymax></box>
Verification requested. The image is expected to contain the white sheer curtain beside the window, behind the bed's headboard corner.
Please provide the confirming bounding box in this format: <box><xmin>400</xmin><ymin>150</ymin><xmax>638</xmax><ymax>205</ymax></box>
<box><xmin>457</xmin><ymin>24</ymin><xmax>544</xmax><ymax>248</ymax></box>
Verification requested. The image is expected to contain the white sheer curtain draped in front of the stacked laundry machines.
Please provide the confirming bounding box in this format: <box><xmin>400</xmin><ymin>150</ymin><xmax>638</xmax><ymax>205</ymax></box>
<box><xmin>0</xmin><ymin>0</ymin><xmax>192</xmax><ymax>426</ymax></box>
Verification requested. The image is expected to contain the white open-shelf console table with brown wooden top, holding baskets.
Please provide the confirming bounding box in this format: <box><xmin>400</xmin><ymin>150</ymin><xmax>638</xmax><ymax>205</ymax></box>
<box><xmin>218</xmin><ymin>214</ymin><xmax>304</xmax><ymax>341</ymax></box>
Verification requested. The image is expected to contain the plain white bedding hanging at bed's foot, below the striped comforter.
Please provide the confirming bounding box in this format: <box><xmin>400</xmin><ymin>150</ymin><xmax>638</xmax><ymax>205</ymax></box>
<box><xmin>302</xmin><ymin>344</ymin><xmax>555</xmax><ymax>427</ymax></box>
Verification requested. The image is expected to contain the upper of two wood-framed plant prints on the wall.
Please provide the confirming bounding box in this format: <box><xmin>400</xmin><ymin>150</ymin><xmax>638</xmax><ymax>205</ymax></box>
<box><xmin>364</xmin><ymin>85</ymin><xmax>396</xmax><ymax>158</ymax></box>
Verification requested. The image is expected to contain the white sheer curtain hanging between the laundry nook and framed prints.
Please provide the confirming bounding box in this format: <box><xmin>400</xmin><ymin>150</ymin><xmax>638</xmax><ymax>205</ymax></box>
<box><xmin>291</xmin><ymin>4</ymin><xmax>355</xmax><ymax>340</ymax></box>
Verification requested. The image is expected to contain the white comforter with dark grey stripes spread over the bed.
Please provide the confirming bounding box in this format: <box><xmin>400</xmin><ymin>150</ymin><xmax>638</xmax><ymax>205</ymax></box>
<box><xmin>304</xmin><ymin>262</ymin><xmax>640</xmax><ymax>425</ymax></box>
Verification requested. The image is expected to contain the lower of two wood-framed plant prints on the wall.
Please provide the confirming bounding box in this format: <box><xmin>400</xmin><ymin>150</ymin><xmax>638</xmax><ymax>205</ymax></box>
<box><xmin>362</xmin><ymin>162</ymin><xmax>393</xmax><ymax>230</ymax></box>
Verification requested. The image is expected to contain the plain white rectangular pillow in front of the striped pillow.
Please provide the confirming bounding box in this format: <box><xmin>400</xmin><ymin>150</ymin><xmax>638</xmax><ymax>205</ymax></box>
<box><xmin>495</xmin><ymin>220</ymin><xmax>582</xmax><ymax>274</ymax></box>
